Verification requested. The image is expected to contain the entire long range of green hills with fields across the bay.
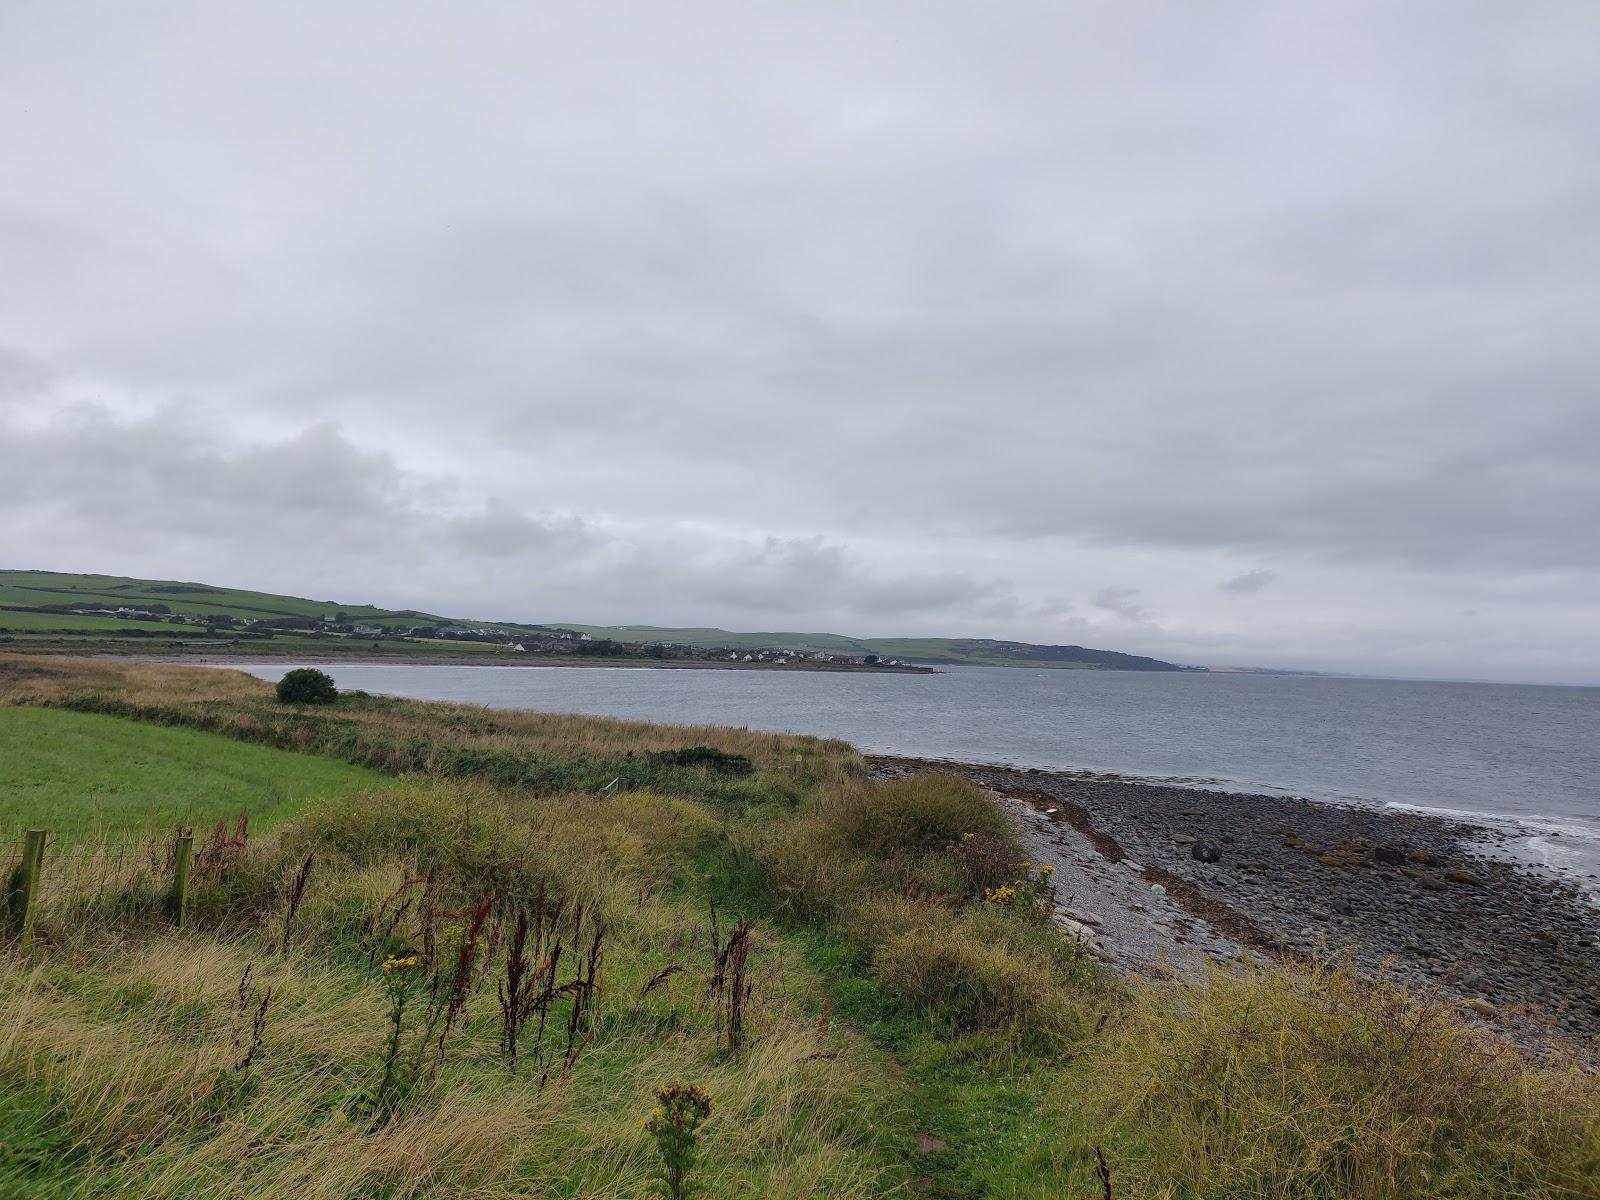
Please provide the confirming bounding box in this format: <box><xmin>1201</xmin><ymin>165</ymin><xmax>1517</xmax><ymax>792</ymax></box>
<box><xmin>0</xmin><ymin>570</ymin><xmax>1184</xmax><ymax>670</ymax></box>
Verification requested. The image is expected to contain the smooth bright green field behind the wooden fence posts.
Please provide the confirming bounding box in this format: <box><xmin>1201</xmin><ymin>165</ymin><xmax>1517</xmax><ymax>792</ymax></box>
<box><xmin>0</xmin><ymin>709</ymin><xmax>392</xmax><ymax>840</ymax></box>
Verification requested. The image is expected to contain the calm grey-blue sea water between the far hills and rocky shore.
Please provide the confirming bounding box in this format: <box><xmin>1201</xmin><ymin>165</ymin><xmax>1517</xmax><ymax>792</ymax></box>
<box><xmin>233</xmin><ymin>662</ymin><xmax>1600</xmax><ymax>875</ymax></box>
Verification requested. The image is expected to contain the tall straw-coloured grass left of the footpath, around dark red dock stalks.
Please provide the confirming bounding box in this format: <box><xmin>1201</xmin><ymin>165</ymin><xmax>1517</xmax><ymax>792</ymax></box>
<box><xmin>0</xmin><ymin>782</ymin><xmax>904</xmax><ymax>1197</ymax></box>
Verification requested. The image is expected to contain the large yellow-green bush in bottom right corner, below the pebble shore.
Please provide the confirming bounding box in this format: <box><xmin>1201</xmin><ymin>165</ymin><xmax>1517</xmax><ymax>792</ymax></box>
<box><xmin>1085</xmin><ymin>966</ymin><xmax>1600</xmax><ymax>1200</ymax></box>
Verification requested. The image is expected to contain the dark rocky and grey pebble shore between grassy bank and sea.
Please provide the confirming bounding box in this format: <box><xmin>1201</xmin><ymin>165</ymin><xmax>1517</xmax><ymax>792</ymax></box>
<box><xmin>872</xmin><ymin>758</ymin><xmax>1600</xmax><ymax>1042</ymax></box>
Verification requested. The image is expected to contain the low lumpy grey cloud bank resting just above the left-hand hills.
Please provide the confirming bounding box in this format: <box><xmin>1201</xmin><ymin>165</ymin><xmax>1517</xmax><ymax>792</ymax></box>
<box><xmin>0</xmin><ymin>408</ymin><xmax>1018</xmax><ymax>629</ymax></box>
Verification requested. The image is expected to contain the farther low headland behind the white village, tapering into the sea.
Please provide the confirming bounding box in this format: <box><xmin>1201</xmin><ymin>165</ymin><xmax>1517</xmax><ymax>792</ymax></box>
<box><xmin>560</xmin><ymin>622</ymin><xmax>1186</xmax><ymax>670</ymax></box>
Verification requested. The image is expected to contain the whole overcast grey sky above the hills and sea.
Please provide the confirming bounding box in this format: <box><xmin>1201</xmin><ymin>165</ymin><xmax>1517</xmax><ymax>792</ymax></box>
<box><xmin>0</xmin><ymin>0</ymin><xmax>1600</xmax><ymax>685</ymax></box>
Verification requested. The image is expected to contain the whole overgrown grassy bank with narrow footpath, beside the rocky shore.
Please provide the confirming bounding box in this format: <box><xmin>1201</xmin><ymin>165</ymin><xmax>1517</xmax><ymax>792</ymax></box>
<box><xmin>0</xmin><ymin>658</ymin><xmax>1600</xmax><ymax>1200</ymax></box>
